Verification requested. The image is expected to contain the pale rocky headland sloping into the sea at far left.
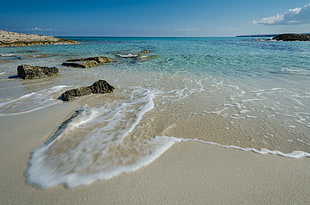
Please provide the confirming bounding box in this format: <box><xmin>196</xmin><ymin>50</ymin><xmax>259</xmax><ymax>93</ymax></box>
<box><xmin>0</xmin><ymin>30</ymin><xmax>78</xmax><ymax>47</ymax></box>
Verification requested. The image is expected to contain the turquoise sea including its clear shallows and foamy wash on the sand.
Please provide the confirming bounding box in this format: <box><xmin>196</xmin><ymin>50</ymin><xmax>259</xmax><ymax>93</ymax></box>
<box><xmin>0</xmin><ymin>37</ymin><xmax>310</xmax><ymax>188</ymax></box>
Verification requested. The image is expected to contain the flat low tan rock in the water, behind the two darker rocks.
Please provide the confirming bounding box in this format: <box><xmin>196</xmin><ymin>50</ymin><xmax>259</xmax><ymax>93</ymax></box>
<box><xmin>62</xmin><ymin>57</ymin><xmax>113</xmax><ymax>68</ymax></box>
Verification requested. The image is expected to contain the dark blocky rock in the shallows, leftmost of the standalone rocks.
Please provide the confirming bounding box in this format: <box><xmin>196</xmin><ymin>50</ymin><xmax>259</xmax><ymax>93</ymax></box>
<box><xmin>17</xmin><ymin>65</ymin><xmax>58</xmax><ymax>79</ymax></box>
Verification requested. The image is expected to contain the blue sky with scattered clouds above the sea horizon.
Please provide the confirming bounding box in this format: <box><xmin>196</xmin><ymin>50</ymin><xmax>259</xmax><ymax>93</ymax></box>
<box><xmin>0</xmin><ymin>0</ymin><xmax>310</xmax><ymax>37</ymax></box>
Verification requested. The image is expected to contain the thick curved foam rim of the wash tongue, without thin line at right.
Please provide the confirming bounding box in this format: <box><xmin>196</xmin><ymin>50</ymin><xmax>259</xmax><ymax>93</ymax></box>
<box><xmin>25</xmin><ymin>136</ymin><xmax>181</xmax><ymax>188</ymax></box>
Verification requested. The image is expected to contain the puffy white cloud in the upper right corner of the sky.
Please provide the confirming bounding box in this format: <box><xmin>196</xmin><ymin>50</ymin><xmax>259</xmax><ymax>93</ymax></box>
<box><xmin>253</xmin><ymin>3</ymin><xmax>310</xmax><ymax>25</ymax></box>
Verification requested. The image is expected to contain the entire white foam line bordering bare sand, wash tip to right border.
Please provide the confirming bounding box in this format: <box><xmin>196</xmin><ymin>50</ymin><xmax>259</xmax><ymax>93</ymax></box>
<box><xmin>25</xmin><ymin>136</ymin><xmax>310</xmax><ymax>188</ymax></box>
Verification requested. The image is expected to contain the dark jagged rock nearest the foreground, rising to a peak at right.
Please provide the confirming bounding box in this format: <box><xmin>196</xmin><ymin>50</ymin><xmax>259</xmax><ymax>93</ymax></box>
<box><xmin>61</xmin><ymin>80</ymin><xmax>115</xmax><ymax>101</ymax></box>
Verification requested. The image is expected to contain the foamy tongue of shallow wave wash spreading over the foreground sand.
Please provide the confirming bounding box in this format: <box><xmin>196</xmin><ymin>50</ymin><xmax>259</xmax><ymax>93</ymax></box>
<box><xmin>26</xmin><ymin>89</ymin><xmax>183</xmax><ymax>188</ymax></box>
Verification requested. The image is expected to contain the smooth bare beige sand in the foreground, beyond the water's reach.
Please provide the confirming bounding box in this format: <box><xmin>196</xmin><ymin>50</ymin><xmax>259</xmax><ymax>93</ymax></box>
<box><xmin>0</xmin><ymin>103</ymin><xmax>310</xmax><ymax>205</ymax></box>
